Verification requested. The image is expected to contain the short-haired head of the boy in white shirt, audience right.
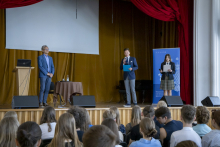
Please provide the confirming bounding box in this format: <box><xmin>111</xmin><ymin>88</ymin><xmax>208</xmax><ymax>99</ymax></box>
<box><xmin>181</xmin><ymin>105</ymin><xmax>196</xmax><ymax>124</ymax></box>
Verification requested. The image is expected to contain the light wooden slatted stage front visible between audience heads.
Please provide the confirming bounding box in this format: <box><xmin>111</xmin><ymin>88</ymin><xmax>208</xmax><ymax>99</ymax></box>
<box><xmin>0</xmin><ymin>103</ymin><xmax>217</xmax><ymax>129</ymax></box>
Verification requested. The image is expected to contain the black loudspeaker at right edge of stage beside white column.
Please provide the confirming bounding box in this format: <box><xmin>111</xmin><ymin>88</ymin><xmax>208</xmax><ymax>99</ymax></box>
<box><xmin>201</xmin><ymin>96</ymin><xmax>220</xmax><ymax>107</ymax></box>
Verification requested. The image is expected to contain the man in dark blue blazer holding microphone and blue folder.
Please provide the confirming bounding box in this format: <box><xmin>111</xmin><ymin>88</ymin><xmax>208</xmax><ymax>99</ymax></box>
<box><xmin>120</xmin><ymin>48</ymin><xmax>138</xmax><ymax>107</ymax></box>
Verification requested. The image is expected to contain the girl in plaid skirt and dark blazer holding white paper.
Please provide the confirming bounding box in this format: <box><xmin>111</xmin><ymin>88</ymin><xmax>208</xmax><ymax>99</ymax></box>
<box><xmin>160</xmin><ymin>54</ymin><xmax>176</xmax><ymax>96</ymax></box>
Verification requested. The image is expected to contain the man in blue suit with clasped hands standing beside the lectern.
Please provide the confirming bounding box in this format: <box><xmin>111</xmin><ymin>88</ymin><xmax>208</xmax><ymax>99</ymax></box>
<box><xmin>38</xmin><ymin>45</ymin><xmax>54</xmax><ymax>107</ymax></box>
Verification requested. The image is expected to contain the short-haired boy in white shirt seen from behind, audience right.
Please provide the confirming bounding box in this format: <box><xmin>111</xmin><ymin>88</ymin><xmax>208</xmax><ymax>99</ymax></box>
<box><xmin>170</xmin><ymin>105</ymin><xmax>202</xmax><ymax>147</ymax></box>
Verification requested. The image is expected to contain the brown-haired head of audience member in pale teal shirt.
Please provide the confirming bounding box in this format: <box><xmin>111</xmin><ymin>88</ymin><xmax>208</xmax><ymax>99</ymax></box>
<box><xmin>196</xmin><ymin>106</ymin><xmax>210</xmax><ymax>124</ymax></box>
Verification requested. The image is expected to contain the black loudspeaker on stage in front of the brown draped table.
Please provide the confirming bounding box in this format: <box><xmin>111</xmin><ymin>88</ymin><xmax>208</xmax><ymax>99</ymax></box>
<box><xmin>70</xmin><ymin>95</ymin><xmax>96</xmax><ymax>107</ymax></box>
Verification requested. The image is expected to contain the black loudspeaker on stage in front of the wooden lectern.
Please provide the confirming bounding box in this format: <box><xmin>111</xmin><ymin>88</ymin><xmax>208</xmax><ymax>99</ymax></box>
<box><xmin>11</xmin><ymin>96</ymin><xmax>39</xmax><ymax>109</ymax></box>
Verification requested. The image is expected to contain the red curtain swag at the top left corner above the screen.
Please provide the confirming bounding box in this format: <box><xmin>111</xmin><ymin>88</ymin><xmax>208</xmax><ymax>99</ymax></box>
<box><xmin>0</xmin><ymin>0</ymin><xmax>43</xmax><ymax>9</ymax></box>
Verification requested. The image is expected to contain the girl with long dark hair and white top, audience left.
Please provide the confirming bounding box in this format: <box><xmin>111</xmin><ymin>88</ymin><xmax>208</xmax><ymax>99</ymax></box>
<box><xmin>40</xmin><ymin>106</ymin><xmax>57</xmax><ymax>140</ymax></box>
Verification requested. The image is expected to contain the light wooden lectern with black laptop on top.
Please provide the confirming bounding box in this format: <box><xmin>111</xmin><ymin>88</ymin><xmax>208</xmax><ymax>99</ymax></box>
<box><xmin>12</xmin><ymin>66</ymin><xmax>34</xmax><ymax>96</ymax></box>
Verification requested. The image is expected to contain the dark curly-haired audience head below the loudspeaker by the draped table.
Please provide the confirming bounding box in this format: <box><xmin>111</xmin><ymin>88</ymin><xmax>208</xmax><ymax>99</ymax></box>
<box><xmin>67</xmin><ymin>106</ymin><xmax>86</xmax><ymax>130</ymax></box>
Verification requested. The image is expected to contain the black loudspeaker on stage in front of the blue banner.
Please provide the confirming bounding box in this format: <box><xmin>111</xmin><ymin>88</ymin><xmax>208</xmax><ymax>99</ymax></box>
<box><xmin>160</xmin><ymin>96</ymin><xmax>183</xmax><ymax>107</ymax></box>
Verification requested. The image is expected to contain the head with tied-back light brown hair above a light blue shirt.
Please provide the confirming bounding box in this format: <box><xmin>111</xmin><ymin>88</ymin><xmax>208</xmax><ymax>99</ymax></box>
<box><xmin>140</xmin><ymin>117</ymin><xmax>157</xmax><ymax>137</ymax></box>
